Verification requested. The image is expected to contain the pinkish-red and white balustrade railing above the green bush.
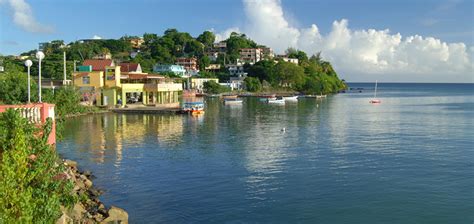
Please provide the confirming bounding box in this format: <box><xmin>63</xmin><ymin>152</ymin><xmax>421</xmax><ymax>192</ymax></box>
<box><xmin>0</xmin><ymin>103</ymin><xmax>56</xmax><ymax>145</ymax></box>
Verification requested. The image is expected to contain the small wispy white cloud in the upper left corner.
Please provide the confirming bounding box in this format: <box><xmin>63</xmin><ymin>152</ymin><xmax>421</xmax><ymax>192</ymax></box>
<box><xmin>0</xmin><ymin>0</ymin><xmax>53</xmax><ymax>33</ymax></box>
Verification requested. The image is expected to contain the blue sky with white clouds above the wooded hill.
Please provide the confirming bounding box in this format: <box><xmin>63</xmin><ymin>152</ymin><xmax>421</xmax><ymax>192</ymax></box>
<box><xmin>0</xmin><ymin>0</ymin><xmax>474</xmax><ymax>83</ymax></box>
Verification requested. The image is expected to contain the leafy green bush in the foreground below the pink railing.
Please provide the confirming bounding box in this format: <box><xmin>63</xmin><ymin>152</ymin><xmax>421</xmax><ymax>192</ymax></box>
<box><xmin>0</xmin><ymin>110</ymin><xmax>77</xmax><ymax>223</ymax></box>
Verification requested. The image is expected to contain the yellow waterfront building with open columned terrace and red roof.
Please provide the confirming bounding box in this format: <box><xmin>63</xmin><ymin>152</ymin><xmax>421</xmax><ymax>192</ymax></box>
<box><xmin>73</xmin><ymin>60</ymin><xmax>183</xmax><ymax>106</ymax></box>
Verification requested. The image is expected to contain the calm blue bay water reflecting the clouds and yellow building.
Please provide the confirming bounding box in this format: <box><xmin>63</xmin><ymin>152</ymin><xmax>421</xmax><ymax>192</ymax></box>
<box><xmin>58</xmin><ymin>83</ymin><xmax>474</xmax><ymax>223</ymax></box>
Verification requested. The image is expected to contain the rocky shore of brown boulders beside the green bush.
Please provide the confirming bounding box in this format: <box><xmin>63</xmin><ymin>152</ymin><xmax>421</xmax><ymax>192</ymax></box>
<box><xmin>56</xmin><ymin>160</ymin><xmax>128</xmax><ymax>224</ymax></box>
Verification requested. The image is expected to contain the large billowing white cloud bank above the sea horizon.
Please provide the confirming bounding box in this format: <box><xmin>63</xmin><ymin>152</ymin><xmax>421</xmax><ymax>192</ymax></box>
<box><xmin>219</xmin><ymin>0</ymin><xmax>474</xmax><ymax>82</ymax></box>
